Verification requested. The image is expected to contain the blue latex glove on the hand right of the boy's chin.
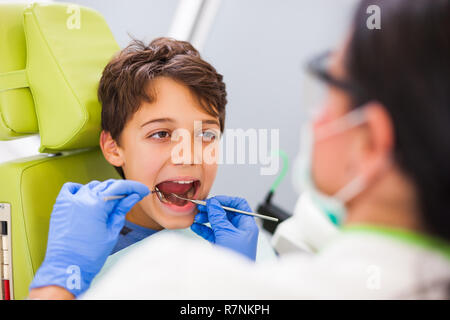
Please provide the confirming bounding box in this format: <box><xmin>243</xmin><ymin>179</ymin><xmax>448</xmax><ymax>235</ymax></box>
<box><xmin>191</xmin><ymin>196</ymin><xmax>259</xmax><ymax>261</ymax></box>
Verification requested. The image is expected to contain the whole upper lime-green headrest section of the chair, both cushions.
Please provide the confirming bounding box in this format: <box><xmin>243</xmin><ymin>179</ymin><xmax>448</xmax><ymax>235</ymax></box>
<box><xmin>0</xmin><ymin>3</ymin><xmax>120</xmax><ymax>152</ymax></box>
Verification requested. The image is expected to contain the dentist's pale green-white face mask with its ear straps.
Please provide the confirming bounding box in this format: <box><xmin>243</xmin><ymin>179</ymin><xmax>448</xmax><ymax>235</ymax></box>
<box><xmin>294</xmin><ymin>107</ymin><xmax>366</xmax><ymax>225</ymax></box>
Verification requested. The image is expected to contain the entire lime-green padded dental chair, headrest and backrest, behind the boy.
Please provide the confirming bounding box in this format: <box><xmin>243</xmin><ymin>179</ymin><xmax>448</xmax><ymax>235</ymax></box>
<box><xmin>0</xmin><ymin>3</ymin><xmax>120</xmax><ymax>299</ymax></box>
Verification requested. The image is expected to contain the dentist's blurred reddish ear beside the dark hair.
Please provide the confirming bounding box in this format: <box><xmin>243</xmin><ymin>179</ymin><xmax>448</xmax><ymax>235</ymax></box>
<box><xmin>362</xmin><ymin>102</ymin><xmax>395</xmax><ymax>180</ymax></box>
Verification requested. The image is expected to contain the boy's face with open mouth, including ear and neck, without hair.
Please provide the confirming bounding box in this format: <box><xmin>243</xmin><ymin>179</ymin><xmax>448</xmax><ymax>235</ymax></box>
<box><xmin>100</xmin><ymin>77</ymin><xmax>220</xmax><ymax>229</ymax></box>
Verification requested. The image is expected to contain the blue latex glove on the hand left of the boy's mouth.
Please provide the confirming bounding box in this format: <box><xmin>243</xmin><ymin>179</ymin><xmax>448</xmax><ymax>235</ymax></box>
<box><xmin>30</xmin><ymin>179</ymin><xmax>150</xmax><ymax>296</ymax></box>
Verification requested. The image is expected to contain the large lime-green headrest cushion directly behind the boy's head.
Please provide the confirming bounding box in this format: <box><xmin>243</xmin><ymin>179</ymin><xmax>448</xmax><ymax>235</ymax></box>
<box><xmin>0</xmin><ymin>3</ymin><xmax>120</xmax><ymax>152</ymax></box>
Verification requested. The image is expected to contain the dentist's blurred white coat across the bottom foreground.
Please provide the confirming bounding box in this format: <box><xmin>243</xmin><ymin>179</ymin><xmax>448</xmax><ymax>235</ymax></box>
<box><xmin>82</xmin><ymin>222</ymin><xmax>450</xmax><ymax>299</ymax></box>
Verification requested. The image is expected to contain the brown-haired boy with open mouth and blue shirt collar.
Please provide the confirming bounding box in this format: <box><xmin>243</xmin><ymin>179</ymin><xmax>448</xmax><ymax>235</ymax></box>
<box><xmin>98</xmin><ymin>38</ymin><xmax>227</xmax><ymax>253</ymax></box>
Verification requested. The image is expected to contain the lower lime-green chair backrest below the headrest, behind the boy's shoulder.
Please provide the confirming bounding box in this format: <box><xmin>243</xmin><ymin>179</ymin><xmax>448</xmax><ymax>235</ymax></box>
<box><xmin>0</xmin><ymin>148</ymin><xmax>119</xmax><ymax>299</ymax></box>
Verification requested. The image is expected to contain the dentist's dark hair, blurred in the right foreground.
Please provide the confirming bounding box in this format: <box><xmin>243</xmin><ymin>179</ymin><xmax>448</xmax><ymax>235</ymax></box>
<box><xmin>345</xmin><ymin>0</ymin><xmax>450</xmax><ymax>241</ymax></box>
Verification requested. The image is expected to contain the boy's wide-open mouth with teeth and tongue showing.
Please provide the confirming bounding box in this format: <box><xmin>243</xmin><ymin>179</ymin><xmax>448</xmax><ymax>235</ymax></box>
<box><xmin>155</xmin><ymin>180</ymin><xmax>200</xmax><ymax>207</ymax></box>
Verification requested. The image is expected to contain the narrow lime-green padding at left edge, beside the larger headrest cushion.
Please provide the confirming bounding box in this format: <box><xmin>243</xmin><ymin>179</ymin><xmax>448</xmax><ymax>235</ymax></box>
<box><xmin>0</xmin><ymin>4</ymin><xmax>38</xmax><ymax>140</ymax></box>
